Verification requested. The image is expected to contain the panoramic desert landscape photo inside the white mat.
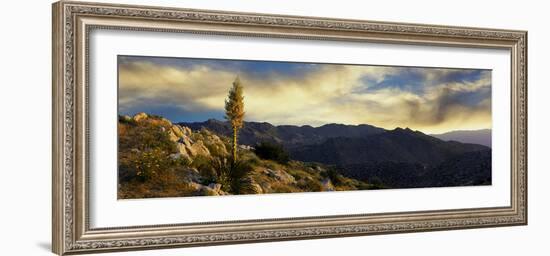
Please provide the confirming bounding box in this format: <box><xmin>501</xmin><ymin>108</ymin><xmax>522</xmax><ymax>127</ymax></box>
<box><xmin>118</xmin><ymin>56</ymin><xmax>492</xmax><ymax>199</ymax></box>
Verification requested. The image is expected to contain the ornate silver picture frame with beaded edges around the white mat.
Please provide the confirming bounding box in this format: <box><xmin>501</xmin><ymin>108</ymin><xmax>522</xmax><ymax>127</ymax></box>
<box><xmin>52</xmin><ymin>1</ymin><xmax>527</xmax><ymax>255</ymax></box>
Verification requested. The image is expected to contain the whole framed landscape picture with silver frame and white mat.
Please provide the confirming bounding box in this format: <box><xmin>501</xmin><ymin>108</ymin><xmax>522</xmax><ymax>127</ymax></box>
<box><xmin>52</xmin><ymin>1</ymin><xmax>527</xmax><ymax>255</ymax></box>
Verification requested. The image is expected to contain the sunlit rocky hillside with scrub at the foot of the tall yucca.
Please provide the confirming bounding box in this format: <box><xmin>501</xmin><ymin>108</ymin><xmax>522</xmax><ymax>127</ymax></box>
<box><xmin>118</xmin><ymin>113</ymin><xmax>381</xmax><ymax>199</ymax></box>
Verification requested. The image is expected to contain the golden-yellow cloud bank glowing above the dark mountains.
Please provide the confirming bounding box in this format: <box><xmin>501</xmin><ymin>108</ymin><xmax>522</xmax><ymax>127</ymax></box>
<box><xmin>119</xmin><ymin>58</ymin><xmax>491</xmax><ymax>133</ymax></box>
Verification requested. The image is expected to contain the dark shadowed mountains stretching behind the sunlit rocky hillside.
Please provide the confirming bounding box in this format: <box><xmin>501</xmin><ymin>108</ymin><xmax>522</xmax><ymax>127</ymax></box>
<box><xmin>179</xmin><ymin>119</ymin><xmax>491</xmax><ymax>187</ymax></box>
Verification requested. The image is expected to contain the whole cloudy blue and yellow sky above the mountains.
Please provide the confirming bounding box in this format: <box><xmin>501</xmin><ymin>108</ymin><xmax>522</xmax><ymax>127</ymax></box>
<box><xmin>118</xmin><ymin>56</ymin><xmax>491</xmax><ymax>133</ymax></box>
